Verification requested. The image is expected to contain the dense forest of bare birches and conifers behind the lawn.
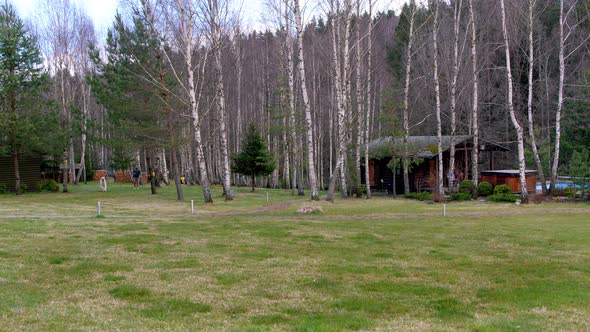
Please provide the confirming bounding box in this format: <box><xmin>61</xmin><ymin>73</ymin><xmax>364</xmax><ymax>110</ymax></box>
<box><xmin>0</xmin><ymin>0</ymin><xmax>590</xmax><ymax>202</ymax></box>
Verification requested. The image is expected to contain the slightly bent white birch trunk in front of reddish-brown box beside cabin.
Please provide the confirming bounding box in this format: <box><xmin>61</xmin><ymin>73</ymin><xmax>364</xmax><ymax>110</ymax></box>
<box><xmin>500</xmin><ymin>0</ymin><xmax>528</xmax><ymax>203</ymax></box>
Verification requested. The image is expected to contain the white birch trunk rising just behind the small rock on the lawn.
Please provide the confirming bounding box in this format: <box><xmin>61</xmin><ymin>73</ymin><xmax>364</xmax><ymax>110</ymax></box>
<box><xmin>294</xmin><ymin>0</ymin><xmax>320</xmax><ymax>201</ymax></box>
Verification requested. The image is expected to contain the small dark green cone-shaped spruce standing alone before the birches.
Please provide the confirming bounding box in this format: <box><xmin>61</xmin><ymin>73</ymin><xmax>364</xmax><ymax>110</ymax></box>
<box><xmin>232</xmin><ymin>125</ymin><xmax>275</xmax><ymax>191</ymax></box>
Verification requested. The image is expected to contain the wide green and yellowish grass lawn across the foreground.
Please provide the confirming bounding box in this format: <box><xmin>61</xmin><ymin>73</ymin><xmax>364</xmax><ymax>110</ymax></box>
<box><xmin>0</xmin><ymin>184</ymin><xmax>590</xmax><ymax>331</ymax></box>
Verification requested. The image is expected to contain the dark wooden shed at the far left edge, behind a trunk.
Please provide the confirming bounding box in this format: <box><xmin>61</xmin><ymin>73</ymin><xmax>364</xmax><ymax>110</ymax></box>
<box><xmin>0</xmin><ymin>156</ymin><xmax>41</xmax><ymax>191</ymax></box>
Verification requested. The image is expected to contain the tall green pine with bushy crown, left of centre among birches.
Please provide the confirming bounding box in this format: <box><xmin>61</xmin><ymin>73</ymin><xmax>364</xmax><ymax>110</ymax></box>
<box><xmin>88</xmin><ymin>8</ymin><xmax>184</xmax><ymax>200</ymax></box>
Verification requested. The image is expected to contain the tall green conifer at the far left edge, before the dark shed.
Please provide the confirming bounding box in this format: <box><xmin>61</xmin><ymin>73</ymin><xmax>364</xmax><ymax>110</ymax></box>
<box><xmin>0</xmin><ymin>4</ymin><xmax>58</xmax><ymax>195</ymax></box>
